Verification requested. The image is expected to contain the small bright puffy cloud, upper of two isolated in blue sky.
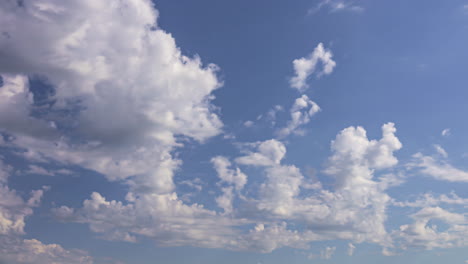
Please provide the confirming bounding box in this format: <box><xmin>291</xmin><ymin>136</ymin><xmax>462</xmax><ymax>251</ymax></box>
<box><xmin>289</xmin><ymin>43</ymin><xmax>336</xmax><ymax>91</ymax></box>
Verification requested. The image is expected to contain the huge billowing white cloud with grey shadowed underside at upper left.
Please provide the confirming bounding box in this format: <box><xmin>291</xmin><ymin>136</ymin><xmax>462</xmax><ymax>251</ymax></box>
<box><xmin>0</xmin><ymin>0</ymin><xmax>222</xmax><ymax>198</ymax></box>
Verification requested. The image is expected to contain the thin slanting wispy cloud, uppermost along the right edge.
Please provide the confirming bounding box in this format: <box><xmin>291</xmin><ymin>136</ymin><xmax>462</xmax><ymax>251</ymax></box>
<box><xmin>407</xmin><ymin>153</ymin><xmax>468</xmax><ymax>182</ymax></box>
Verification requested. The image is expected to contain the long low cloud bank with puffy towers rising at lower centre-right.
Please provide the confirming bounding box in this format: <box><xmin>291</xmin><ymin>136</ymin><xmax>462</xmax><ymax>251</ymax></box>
<box><xmin>50</xmin><ymin>123</ymin><xmax>401</xmax><ymax>252</ymax></box>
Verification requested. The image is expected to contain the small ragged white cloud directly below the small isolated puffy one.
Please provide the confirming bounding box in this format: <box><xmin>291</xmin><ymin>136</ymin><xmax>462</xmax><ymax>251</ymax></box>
<box><xmin>277</xmin><ymin>95</ymin><xmax>320</xmax><ymax>138</ymax></box>
